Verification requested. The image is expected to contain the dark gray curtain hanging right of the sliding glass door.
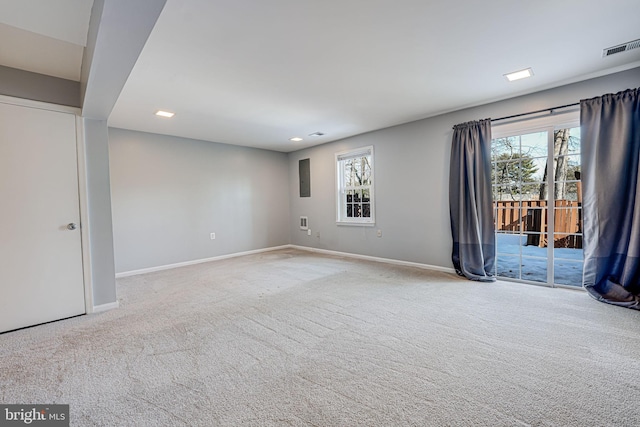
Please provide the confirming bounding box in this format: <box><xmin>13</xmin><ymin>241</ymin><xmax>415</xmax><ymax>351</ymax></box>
<box><xmin>580</xmin><ymin>89</ymin><xmax>640</xmax><ymax>309</ymax></box>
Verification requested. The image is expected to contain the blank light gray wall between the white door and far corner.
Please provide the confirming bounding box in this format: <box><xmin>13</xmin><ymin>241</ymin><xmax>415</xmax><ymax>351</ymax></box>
<box><xmin>109</xmin><ymin>128</ymin><xmax>290</xmax><ymax>273</ymax></box>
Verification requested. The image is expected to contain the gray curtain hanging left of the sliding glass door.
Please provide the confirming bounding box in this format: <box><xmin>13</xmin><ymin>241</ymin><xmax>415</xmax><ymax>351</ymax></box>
<box><xmin>449</xmin><ymin>119</ymin><xmax>496</xmax><ymax>282</ymax></box>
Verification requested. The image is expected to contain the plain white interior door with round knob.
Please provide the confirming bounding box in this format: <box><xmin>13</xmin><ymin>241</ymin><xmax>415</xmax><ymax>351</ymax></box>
<box><xmin>0</xmin><ymin>103</ymin><xmax>85</xmax><ymax>332</ymax></box>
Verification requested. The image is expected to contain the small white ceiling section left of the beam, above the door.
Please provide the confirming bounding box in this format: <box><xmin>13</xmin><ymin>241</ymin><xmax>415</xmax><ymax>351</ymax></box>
<box><xmin>0</xmin><ymin>0</ymin><xmax>93</xmax><ymax>81</ymax></box>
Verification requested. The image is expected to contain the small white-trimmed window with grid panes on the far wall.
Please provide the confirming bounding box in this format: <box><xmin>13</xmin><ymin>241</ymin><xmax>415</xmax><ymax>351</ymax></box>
<box><xmin>336</xmin><ymin>146</ymin><xmax>375</xmax><ymax>225</ymax></box>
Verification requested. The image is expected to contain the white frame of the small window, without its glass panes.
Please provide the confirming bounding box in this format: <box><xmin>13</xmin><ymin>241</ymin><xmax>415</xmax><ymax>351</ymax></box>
<box><xmin>336</xmin><ymin>145</ymin><xmax>376</xmax><ymax>226</ymax></box>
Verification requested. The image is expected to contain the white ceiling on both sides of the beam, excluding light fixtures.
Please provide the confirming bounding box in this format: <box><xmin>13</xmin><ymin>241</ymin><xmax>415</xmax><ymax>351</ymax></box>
<box><xmin>0</xmin><ymin>0</ymin><xmax>640</xmax><ymax>152</ymax></box>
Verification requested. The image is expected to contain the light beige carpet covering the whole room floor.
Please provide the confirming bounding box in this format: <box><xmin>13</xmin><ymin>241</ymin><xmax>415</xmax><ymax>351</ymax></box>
<box><xmin>0</xmin><ymin>250</ymin><xmax>640</xmax><ymax>426</ymax></box>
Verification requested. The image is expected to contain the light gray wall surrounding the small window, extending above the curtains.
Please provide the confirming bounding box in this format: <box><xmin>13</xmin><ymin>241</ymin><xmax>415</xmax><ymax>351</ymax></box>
<box><xmin>289</xmin><ymin>68</ymin><xmax>640</xmax><ymax>267</ymax></box>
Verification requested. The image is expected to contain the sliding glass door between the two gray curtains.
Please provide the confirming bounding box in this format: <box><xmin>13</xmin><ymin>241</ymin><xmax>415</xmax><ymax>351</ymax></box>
<box><xmin>492</xmin><ymin>118</ymin><xmax>582</xmax><ymax>287</ymax></box>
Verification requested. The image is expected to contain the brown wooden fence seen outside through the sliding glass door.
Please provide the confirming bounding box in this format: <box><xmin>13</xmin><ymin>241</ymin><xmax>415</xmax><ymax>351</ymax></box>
<box><xmin>495</xmin><ymin>200</ymin><xmax>582</xmax><ymax>248</ymax></box>
